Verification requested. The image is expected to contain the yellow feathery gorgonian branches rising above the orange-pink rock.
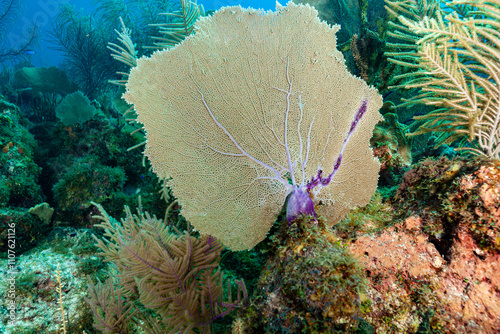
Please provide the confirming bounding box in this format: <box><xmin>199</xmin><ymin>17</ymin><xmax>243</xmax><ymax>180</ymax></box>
<box><xmin>389</xmin><ymin>0</ymin><xmax>500</xmax><ymax>159</ymax></box>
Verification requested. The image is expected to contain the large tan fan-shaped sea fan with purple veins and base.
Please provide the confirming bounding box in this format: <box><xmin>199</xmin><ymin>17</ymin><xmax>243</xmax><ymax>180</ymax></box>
<box><xmin>124</xmin><ymin>3</ymin><xmax>382</xmax><ymax>250</ymax></box>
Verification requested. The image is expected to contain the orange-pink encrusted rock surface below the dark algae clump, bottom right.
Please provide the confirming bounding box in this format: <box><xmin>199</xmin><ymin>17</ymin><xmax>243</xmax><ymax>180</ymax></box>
<box><xmin>350</xmin><ymin>216</ymin><xmax>500</xmax><ymax>333</ymax></box>
